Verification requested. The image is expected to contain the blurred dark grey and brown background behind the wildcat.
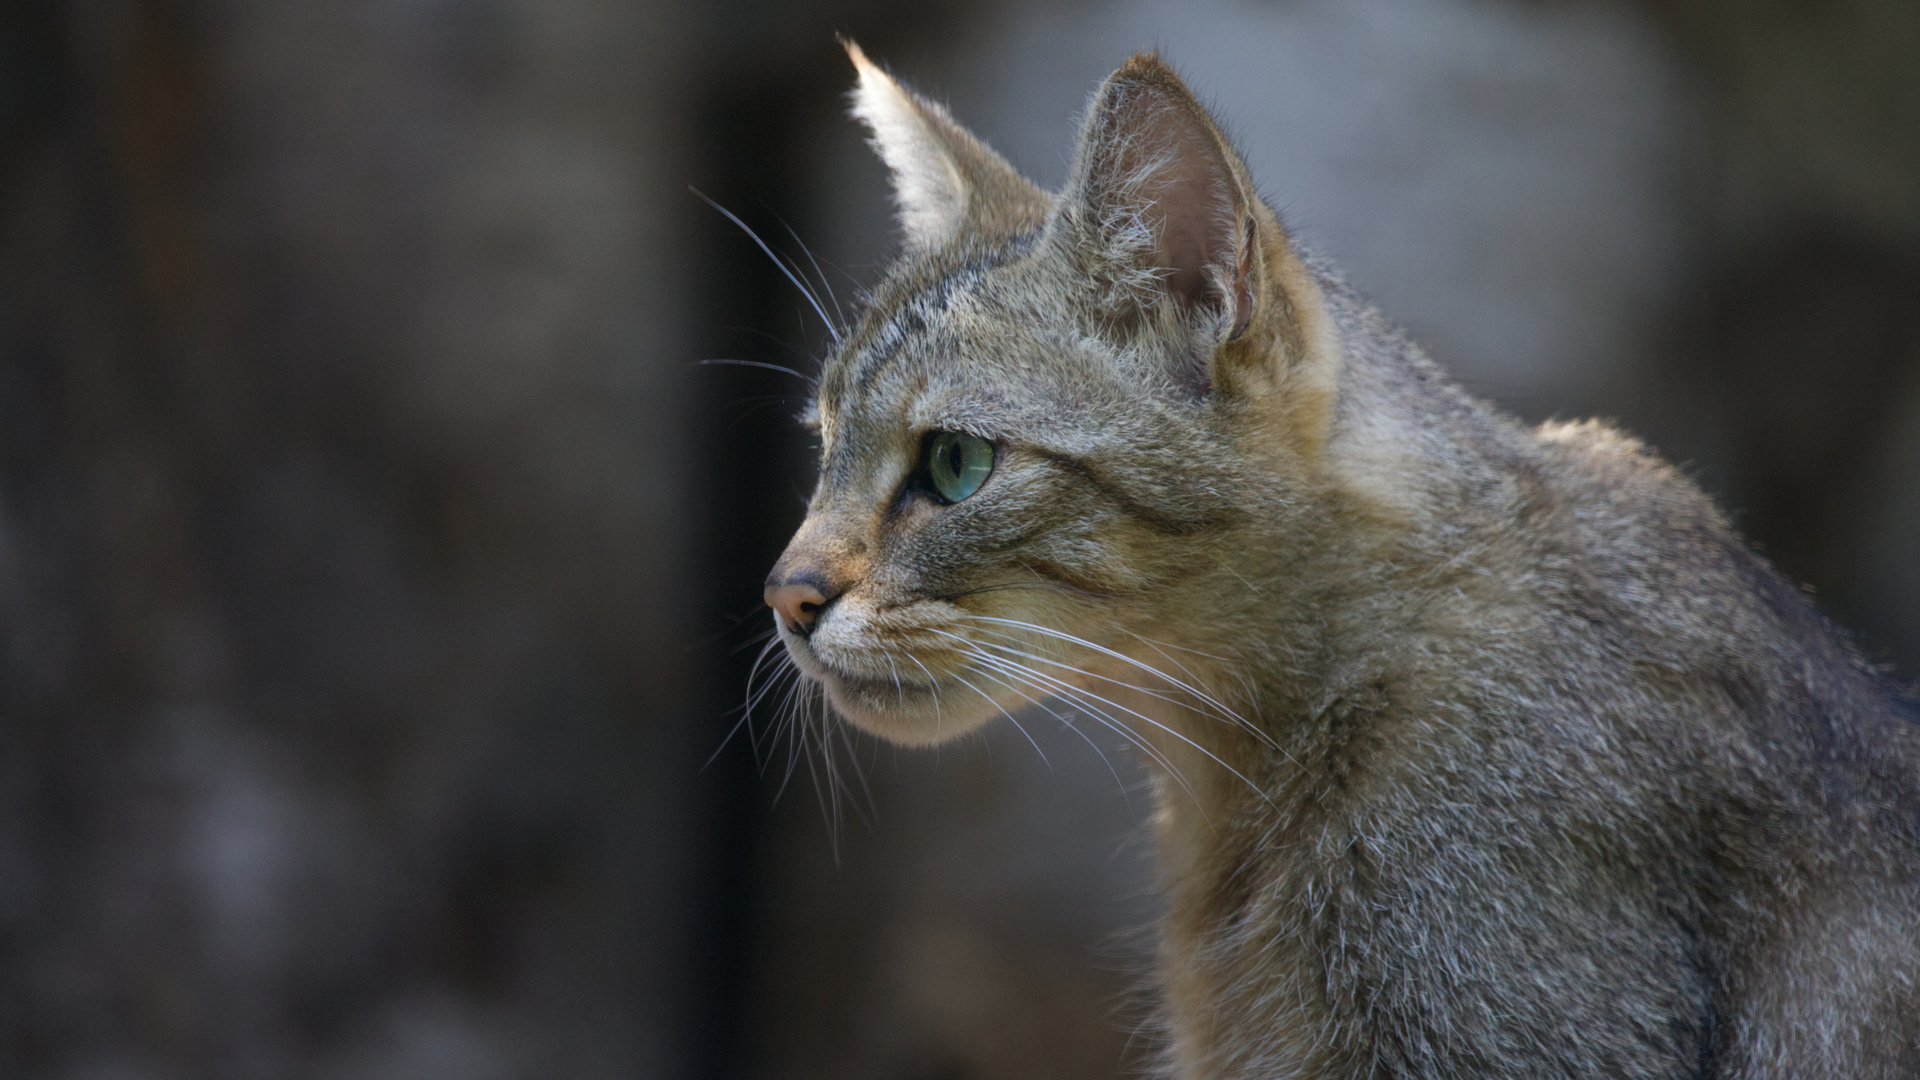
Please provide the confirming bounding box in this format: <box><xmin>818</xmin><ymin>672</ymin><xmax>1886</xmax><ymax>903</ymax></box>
<box><xmin>0</xmin><ymin>0</ymin><xmax>1920</xmax><ymax>1080</ymax></box>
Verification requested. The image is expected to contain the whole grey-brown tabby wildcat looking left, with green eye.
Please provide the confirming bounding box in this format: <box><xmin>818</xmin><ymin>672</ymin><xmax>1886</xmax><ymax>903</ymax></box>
<box><xmin>766</xmin><ymin>44</ymin><xmax>1920</xmax><ymax>1078</ymax></box>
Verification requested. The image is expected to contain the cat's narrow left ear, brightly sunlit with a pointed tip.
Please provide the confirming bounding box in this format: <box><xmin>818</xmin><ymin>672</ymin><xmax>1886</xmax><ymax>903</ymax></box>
<box><xmin>841</xmin><ymin>38</ymin><xmax>1050</xmax><ymax>252</ymax></box>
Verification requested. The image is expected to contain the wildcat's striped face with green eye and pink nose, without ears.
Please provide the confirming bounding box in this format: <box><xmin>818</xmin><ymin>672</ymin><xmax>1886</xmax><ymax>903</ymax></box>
<box><xmin>768</xmin><ymin>247</ymin><xmax>1236</xmax><ymax>744</ymax></box>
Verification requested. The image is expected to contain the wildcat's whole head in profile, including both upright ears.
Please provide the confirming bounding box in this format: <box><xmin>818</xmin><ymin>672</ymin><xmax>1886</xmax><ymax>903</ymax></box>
<box><xmin>766</xmin><ymin>46</ymin><xmax>1338</xmax><ymax>744</ymax></box>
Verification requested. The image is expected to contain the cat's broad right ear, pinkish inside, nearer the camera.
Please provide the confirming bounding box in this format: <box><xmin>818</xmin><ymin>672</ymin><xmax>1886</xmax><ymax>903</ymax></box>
<box><xmin>1052</xmin><ymin>54</ymin><xmax>1265</xmax><ymax>388</ymax></box>
